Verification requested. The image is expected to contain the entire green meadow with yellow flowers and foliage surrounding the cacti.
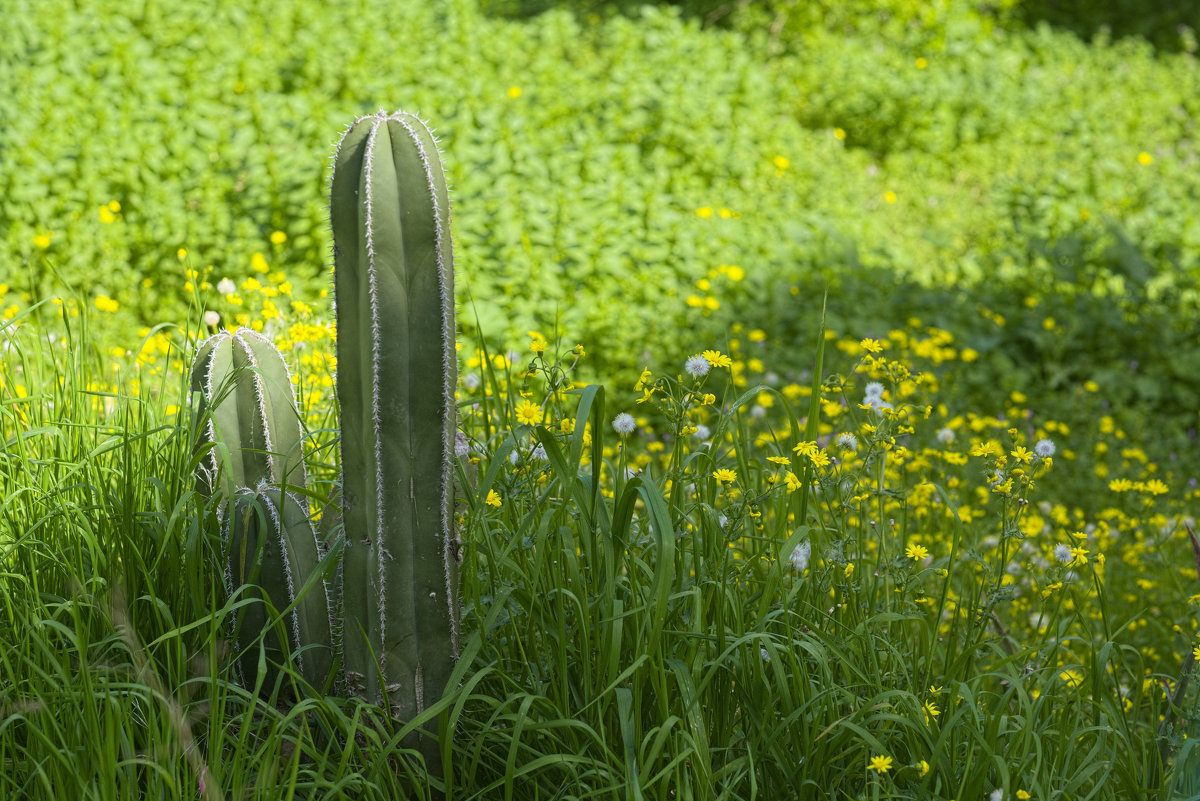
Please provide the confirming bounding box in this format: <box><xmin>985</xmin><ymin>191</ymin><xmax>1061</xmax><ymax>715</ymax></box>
<box><xmin>0</xmin><ymin>0</ymin><xmax>1200</xmax><ymax>801</ymax></box>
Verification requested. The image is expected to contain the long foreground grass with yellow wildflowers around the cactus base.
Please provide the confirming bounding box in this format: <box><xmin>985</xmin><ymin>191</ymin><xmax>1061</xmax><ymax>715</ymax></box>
<box><xmin>0</xmin><ymin>301</ymin><xmax>1195</xmax><ymax>799</ymax></box>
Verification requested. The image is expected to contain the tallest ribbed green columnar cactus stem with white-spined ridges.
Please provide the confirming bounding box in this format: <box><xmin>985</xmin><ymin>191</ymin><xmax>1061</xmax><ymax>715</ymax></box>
<box><xmin>330</xmin><ymin>112</ymin><xmax>458</xmax><ymax>719</ymax></box>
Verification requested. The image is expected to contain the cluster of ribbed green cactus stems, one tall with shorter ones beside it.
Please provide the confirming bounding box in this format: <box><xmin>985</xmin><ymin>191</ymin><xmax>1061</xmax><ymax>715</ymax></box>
<box><xmin>192</xmin><ymin>112</ymin><xmax>458</xmax><ymax>773</ymax></box>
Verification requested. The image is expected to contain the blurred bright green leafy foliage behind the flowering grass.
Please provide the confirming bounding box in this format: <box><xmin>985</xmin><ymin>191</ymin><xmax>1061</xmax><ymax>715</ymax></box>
<box><xmin>0</xmin><ymin>0</ymin><xmax>1200</xmax><ymax>462</ymax></box>
